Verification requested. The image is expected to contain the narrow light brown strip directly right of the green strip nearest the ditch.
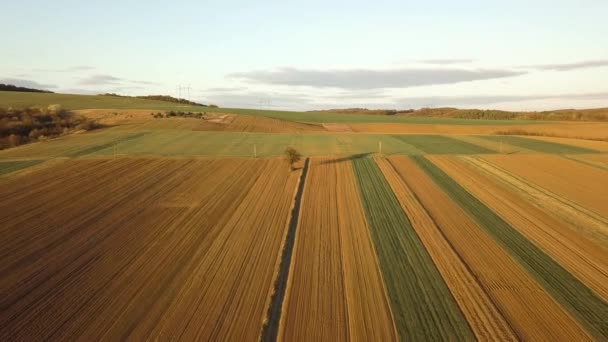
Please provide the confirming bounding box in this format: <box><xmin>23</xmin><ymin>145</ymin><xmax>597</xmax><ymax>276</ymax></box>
<box><xmin>376</xmin><ymin>158</ymin><xmax>517</xmax><ymax>341</ymax></box>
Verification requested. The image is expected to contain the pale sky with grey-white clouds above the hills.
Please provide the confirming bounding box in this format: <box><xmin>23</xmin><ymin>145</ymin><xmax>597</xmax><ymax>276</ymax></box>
<box><xmin>0</xmin><ymin>0</ymin><xmax>608</xmax><ymax>110</ymax></box>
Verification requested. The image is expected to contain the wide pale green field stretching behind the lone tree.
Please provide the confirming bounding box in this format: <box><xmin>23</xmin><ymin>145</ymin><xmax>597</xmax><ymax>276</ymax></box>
<box><xmin>0</xmin><ymin>127</ymin><xmax>422</xmax><ymax>160</ymax></box>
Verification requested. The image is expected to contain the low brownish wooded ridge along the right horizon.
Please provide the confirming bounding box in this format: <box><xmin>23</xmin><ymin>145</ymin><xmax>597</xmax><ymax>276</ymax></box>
<box><xmin>314</xmin><ymin>107</ymin><xmax>608</xmax><ymax>121</ymax></box>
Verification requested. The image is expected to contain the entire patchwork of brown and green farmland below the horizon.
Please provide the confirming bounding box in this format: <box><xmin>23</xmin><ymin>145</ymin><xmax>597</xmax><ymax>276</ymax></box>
<box><xmin>0</xmin><ymin>93</ymin><xmax>608</xmax><ymax>341</ymax></box>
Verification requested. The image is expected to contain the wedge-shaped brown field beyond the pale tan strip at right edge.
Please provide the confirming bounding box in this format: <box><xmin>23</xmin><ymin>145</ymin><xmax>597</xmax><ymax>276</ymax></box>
<box><xmin>482</xmin><ymin>154</ymin><xmax>608</xmax><ymax>218</ymax></box>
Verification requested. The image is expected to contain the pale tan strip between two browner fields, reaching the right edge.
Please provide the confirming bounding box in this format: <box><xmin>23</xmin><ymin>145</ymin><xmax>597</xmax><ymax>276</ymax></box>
<box><xmin>462</xmin><ymin>156</ymin><xmax>608</xmax><ymax>247</ymax></box>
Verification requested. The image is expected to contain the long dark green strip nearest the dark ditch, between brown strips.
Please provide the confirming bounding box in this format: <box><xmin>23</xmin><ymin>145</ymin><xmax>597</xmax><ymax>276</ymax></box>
<box><xmin>352</xmin><ymin>158</ymin><xmax>474</xmax><ymax>341</ymax></box>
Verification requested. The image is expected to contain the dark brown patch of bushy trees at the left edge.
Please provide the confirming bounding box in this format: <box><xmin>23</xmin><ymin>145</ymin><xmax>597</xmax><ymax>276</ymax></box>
<box><xmin>0</xmin><ymin>105</ymin><xmax>101</xmax><ymax>149</ymax></box>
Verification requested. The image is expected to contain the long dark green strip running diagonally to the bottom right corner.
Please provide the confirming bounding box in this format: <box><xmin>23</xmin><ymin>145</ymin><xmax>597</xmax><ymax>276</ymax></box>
<box><xmin>411</xmin><ymin>156</ymin><xmax>608</xmax><ymax>340</ymax></box>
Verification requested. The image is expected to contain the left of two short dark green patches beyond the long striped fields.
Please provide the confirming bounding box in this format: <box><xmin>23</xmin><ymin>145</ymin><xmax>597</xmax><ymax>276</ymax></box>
<box><xmin>392</xmin><ymin>134</ymin><xmax>496</xmax><ymax>154</ymax></box>
